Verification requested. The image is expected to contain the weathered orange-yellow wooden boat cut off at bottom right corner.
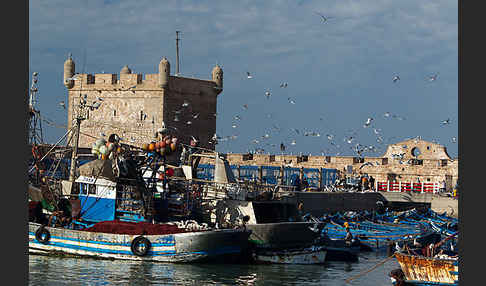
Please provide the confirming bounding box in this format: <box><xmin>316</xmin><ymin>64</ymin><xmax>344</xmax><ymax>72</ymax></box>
<box><xmin>391</xmin><ymin>252</ymin><xmax>459</xmax><ymax>285</ymax></box>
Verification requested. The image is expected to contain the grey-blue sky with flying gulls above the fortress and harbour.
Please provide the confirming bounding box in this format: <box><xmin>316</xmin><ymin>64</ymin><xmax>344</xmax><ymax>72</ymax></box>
<box><xmin>29</xmin><ymin>0</ymin><xmax>459</xmax><ymax>157</ymax></box>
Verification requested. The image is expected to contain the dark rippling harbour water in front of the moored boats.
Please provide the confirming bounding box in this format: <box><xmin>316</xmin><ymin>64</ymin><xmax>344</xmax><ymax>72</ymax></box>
<box><xmin>29</xmin><ymin>252</ymin><xmax>399</xmax><ymax>286</ymax></box>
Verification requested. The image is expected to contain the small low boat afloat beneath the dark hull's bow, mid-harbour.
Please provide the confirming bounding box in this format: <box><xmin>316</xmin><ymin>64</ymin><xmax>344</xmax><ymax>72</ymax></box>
<box><xmin>253</xmin><ymin>246</ymin><xmax>327</xmax><ymax>264</ymax></box>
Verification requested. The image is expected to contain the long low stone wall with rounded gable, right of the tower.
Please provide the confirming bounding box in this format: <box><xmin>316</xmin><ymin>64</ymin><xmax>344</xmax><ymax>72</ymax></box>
<box><xmin>201</xmin><ymin>139</ymin><xmax>459</xmax><ymax>191</ymax></box>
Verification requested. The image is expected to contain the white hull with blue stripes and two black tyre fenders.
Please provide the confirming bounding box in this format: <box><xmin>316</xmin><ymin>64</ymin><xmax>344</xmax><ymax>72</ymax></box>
<box><xmin>29</xmin><ymin>223</ymin><xmax>250</xmax><ymax>263</ymax></box>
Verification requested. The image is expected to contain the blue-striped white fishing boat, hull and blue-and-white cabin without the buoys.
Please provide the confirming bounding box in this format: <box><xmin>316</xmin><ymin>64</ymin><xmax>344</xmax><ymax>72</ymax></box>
<box><xmin>28</xmin><ymin>155</ymin><xmax>251</xmax><ymax>263</ymax></box>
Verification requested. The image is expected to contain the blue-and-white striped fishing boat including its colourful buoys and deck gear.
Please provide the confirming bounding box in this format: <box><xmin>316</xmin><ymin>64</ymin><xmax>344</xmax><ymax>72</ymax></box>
<box><xmin>28</xmin><ymin>124</ymin><xmax>251</xmax><ymax>263</ymax></box>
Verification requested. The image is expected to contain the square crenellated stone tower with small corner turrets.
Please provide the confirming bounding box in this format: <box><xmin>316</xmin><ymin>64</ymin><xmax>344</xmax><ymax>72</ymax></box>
<box><xmin>63</xmin><ymin>57</ymin><xmax>223</xmax><ymax>150</ymax></box>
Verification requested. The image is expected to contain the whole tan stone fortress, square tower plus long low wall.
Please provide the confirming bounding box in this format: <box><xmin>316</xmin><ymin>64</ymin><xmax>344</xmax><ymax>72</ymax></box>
<box><xmin>64</xmin><ymin>54</ymin><xmax>458</xmax><ymax>191</ymax></box>
